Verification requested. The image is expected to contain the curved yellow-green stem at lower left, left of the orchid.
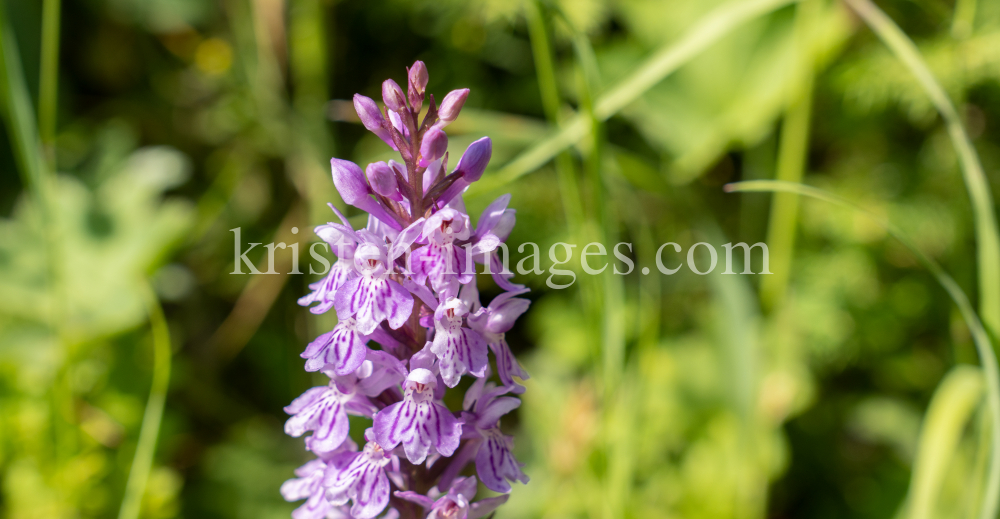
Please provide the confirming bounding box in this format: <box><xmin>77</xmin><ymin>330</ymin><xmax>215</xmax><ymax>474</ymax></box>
<box><xmin>118</xmin><ymin>280</ymin><xmax>171</xmax><ymax>519</ymax></box>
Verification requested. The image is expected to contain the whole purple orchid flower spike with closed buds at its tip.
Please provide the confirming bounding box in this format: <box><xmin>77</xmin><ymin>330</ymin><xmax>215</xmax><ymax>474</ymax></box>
<box><xmin>281</xmin><ymin>61</ymin><xmax>529</xmax><ymax>519</ymax></box>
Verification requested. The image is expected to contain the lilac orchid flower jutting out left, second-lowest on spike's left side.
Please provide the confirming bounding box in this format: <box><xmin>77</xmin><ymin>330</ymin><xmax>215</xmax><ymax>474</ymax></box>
<box><xmin>285</xmin><ymin>380</ymin><xmax>377</xmax><ymax>451</ymax></box>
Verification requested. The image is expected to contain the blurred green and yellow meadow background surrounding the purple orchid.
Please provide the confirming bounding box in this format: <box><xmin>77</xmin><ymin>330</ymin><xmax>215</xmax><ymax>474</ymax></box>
<box><xmin>0</xmin><ymin>0</ymin><xmax>1000</xmax><ymax>519</ymax></box>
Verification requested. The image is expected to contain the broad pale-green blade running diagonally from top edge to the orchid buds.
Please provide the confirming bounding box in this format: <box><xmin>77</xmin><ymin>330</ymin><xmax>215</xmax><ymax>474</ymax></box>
<box><xmin>467</xmin><ymin>0</ymin><xmax>797</xmax><ymax>197</ymax></box>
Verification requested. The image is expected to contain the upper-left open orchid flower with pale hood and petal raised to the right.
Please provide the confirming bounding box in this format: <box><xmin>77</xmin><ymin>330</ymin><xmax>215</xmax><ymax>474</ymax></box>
<box><xmin>334</xmin><ymin>218</ymin><xmax>424</xmax><ymax>335</ymax></box>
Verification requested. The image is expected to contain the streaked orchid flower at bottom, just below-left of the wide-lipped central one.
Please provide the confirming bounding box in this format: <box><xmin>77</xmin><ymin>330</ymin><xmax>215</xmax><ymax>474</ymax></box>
<box><xmin>323</xmin><ymin>428</ymin><xmax>399</xmax><ymax>519</ymax></box>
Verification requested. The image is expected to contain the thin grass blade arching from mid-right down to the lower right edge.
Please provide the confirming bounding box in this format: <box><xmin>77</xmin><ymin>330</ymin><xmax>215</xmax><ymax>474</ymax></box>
<box><xmin>725</xmin><ymin>180</ymin><xmax>1000</xmax><ymax>519</ymax></box>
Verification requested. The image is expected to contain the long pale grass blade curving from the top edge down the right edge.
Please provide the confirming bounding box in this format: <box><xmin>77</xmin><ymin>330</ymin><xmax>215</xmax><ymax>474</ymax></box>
<box><xmin>846</xmin><ymin>0</ymin><xmax>1000</xmax><ymax>348</ymax></box>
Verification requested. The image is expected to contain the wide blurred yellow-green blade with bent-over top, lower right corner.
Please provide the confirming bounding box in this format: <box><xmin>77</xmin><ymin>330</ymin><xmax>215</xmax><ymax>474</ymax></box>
<box><xmin>907</xmin><ymin>364</ymin><xmax>983</xmax><ymax>519</ymax></box>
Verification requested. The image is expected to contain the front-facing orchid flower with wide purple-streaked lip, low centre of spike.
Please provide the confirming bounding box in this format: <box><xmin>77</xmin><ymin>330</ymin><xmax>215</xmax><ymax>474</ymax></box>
<box><xmin>375</xmin><ymin>368</ymin><xmax>462</xmax><ymax>465</ymax></box>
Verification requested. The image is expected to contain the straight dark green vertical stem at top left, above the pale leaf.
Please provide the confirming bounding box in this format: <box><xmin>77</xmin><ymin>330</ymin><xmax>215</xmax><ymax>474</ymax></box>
<box><xmin>38</xmin><ymin>0</ymin><xmax>62</xmax><ymax>161</ymax></box>
